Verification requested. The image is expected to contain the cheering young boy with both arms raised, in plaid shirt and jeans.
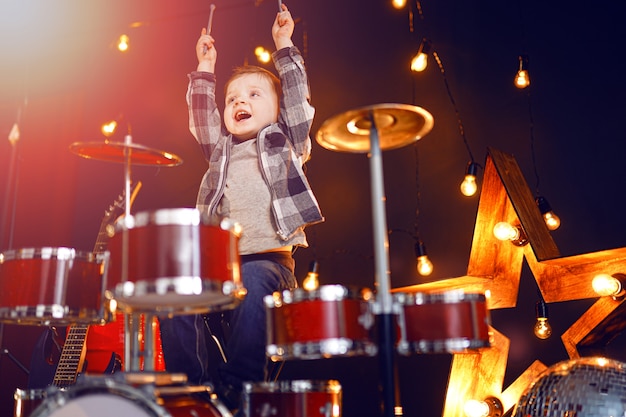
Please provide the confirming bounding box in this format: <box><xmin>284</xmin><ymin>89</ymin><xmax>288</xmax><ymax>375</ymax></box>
<box><xmin>161</xmin><ymin>4</ymin><xmax>324</xmax><ymax>409</ymax></box>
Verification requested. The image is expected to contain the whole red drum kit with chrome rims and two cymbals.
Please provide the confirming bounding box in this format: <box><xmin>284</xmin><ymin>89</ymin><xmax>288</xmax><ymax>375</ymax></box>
<box><xmin>0</xmin><ymin>104</ymin><xmax>489</xmax><ymax>417</ymax></box>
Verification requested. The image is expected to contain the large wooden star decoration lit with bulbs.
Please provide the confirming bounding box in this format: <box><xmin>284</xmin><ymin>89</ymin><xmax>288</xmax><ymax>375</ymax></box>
<box><xmin>393</xmin><ymin>148</ymin><xmax>626</xmax><ymax>417</ymax></box>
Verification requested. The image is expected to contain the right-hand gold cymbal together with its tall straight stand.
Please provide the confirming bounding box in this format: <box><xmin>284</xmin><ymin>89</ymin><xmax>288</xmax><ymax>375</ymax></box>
<box><xmin>317</xmin><ymin>104</ymin><xmax>433</xmax><ymax>417</ymax></box>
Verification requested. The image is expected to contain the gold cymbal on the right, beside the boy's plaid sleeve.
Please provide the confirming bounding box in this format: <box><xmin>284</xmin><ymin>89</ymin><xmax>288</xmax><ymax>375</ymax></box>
<box><xmin>316</xmin><ymin>103</ymin><xmax>434</xmax><ymax>153</ymax></box>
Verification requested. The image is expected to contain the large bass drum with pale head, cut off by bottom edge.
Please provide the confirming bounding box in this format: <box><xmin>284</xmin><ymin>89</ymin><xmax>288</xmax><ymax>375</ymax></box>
<box><xmin>30</xmin><ymin>377</ymin><xmax>232</xmax><ymax>417</ymax></box>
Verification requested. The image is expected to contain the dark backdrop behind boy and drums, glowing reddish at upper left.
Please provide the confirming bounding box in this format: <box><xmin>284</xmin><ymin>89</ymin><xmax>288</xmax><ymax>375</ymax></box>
<box><xmin>0</xmin><ymin>0</ymin><xmax>626</xmax><ymax>417</ymax></box>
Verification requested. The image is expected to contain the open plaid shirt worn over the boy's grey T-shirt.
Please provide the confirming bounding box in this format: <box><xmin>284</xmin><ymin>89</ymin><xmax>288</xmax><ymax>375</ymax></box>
<box><xmin>187</xmin><ymin>46</ymin><xmax>324</xmax><ymax>240</ymax></box>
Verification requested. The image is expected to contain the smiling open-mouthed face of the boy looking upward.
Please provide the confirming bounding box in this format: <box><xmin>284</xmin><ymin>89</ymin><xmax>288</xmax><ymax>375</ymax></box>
<box><xmin>224</xmin><ymin>74</ymin><xmax>278</xmax><ymax>141</ymax></box>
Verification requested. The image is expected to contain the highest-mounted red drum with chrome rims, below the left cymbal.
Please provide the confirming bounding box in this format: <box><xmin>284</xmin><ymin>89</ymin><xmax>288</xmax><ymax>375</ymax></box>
<box><xmin>109</xmin><ymin>208</ymin><xmax>245</xmax><ymax>314</ymax></box>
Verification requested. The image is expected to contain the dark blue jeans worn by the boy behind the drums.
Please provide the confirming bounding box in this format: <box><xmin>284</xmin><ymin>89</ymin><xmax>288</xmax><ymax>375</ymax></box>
<box><xmin>160</xmin><ymin>253</ymin><xmax>297</xmax><ymax>391</ymax></box>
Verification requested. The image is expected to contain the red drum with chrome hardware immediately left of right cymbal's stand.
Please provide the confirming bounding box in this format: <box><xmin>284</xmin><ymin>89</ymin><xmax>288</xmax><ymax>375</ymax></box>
<box><xmin>264</xmin><ymin>285</ymin><xmax>377</xmax><ymax>360</ymax></box>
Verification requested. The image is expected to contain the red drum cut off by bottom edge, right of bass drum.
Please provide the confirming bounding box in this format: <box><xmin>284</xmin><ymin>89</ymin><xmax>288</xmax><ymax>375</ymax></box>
<box><xmin>243</xmin><ymin>380</ymin><xmax>341</xmax><ymax>417</ymax></box>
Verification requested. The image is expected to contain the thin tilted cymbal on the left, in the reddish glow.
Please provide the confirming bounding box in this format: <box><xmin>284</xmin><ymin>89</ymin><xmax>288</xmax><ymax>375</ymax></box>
<box><xmin>70</xmin><ymin>140</ymin><xmax>183</xmax><ymax>167</ymax></box>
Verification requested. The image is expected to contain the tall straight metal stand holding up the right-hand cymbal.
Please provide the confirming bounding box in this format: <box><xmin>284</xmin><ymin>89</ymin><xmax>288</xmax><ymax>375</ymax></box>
<box><xmin>368</xmin><ymin>110</ymin><xmax>395</xmax><ymax>417</ymax></box>
